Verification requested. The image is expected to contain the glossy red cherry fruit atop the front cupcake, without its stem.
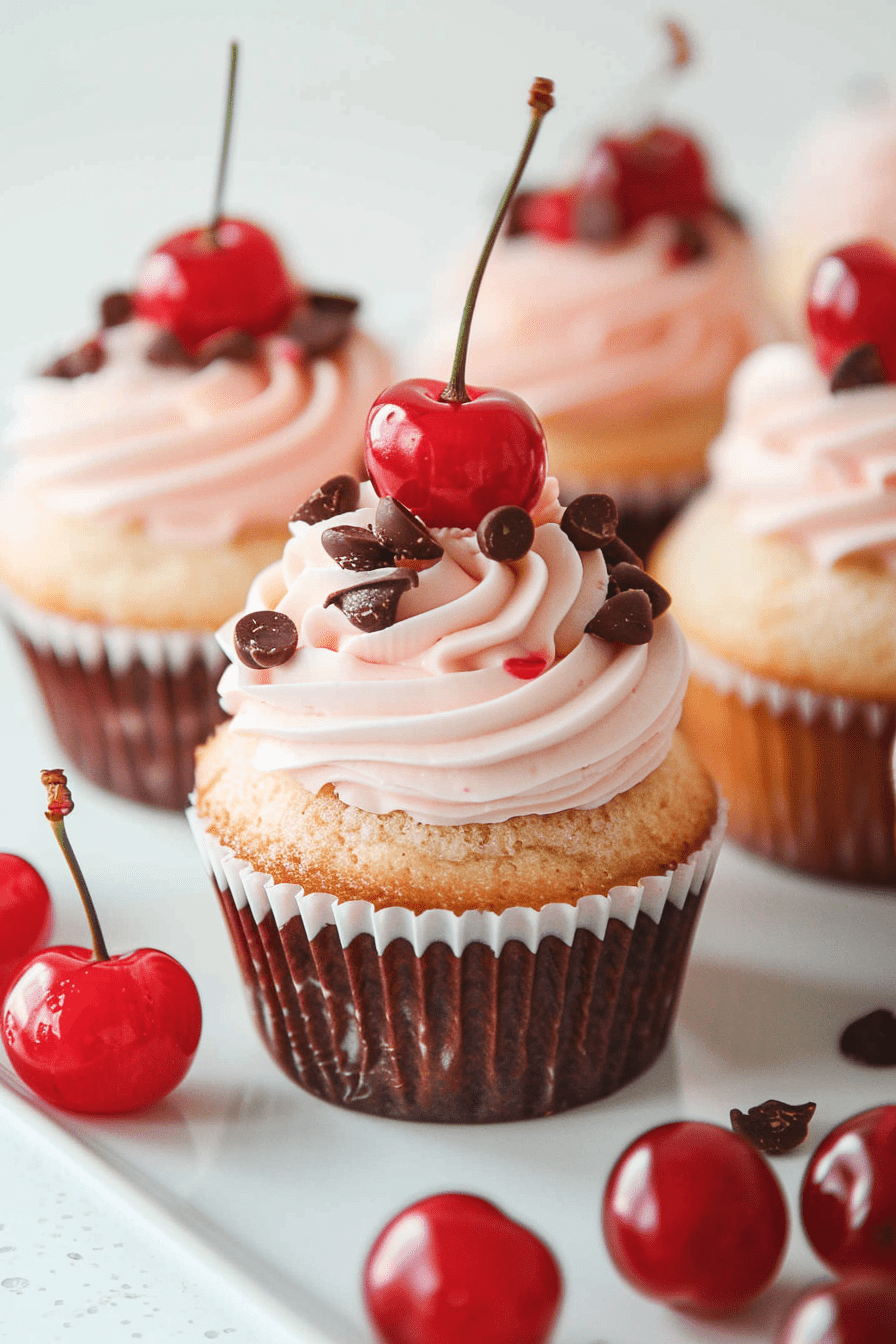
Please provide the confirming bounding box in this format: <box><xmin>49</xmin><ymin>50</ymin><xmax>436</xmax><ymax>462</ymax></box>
<box><xmin>364</xmin><ymin>378</ymin><xmax>548</xmax><ymax>528</ymax></box>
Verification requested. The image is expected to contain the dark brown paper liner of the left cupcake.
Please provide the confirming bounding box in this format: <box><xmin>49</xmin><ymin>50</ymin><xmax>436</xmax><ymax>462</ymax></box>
<box><xmin>1</xmin><ymin>593</ymin><xmax>227</xmax><ymax>809</ymax></box>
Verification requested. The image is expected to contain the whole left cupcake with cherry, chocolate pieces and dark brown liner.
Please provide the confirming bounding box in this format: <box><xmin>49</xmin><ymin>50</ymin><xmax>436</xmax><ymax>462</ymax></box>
<box><xmin>0</xmin><ymin>218</ymin><xmax>388</xmax><ymax>808</ymax></box>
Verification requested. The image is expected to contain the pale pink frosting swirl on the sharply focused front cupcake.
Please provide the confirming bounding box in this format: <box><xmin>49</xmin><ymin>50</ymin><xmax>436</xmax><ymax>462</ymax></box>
<box><xmin>220</xmin><ymin>480</ymin><xmax>686</xmax><ymax>825</ymax></box>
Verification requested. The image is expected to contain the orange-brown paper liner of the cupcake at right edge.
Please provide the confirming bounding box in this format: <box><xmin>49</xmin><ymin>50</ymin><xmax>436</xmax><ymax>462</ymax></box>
<box><xmin>681</xmin><ymin>644</ymin><xmax>896</xmax><ymax>884</ymax></box>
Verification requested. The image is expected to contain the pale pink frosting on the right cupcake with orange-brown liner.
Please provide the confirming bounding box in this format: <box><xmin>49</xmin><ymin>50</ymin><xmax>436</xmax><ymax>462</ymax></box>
<box><xmin>711</xmin><ymin>343</ymin><xmax>896</xmax><ymax>569</ymax></box>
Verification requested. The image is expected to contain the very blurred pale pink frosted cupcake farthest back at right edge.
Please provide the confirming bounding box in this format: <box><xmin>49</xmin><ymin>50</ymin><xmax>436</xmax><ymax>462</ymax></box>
<box><xmin>771</xmin><ymin>83</ymin><xmax>896</xmax><ymax>336</ymax></box>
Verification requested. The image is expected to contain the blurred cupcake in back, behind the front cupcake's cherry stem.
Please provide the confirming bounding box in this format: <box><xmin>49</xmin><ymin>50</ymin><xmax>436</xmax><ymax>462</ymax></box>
<box><xmin>416</xmin><ymin>34</ymin><xmax>772</xmax><ymax>554</ymax></box>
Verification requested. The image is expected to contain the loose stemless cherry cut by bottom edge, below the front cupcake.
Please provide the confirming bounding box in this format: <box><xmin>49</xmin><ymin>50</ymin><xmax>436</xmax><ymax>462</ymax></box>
<box><xmin>364</xmin><ymin>1193</ymin><xmax>563</xmax><ymax>1344</ymax></box>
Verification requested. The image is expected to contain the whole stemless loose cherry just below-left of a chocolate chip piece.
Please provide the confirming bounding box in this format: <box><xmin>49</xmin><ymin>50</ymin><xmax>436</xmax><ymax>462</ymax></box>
<box><xmin>603</xmin><ymin>1121</ymin><xmax>787</xmax><ymax>1316</ymax></box>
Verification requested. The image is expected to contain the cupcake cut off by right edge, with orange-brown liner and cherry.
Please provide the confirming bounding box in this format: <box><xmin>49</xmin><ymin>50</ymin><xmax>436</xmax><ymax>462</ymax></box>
<box><xmin>652</xmin><ymin>243</ymin><xmax>896</xmax><ymax>883</ymax></box>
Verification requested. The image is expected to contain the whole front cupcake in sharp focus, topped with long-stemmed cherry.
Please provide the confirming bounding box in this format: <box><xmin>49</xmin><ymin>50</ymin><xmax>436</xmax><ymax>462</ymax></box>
<box><xmin>192</xmin><ymin>81</ymin><xmax>721</xmax><ymax>1122</ymax></box>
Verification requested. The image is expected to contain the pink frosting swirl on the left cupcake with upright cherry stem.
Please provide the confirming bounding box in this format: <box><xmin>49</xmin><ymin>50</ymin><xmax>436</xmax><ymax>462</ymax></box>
<box><xmin>5</xmin><ymin>321</ymin><xmax>390</xmax><ymax>546</ymax></box>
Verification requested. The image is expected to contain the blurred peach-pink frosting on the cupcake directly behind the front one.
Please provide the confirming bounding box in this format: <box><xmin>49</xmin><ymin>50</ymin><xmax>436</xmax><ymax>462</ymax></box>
<box><xmin>422</xmin><ymin>218</ymin><xmax>772</xmax><ymax>417</ymax></box>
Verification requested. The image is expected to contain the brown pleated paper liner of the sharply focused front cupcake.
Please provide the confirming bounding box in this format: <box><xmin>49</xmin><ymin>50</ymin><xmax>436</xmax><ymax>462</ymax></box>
<box><xmin>188</xmin><ymin>804</ymin><xmax>724</xmax><ymax>1124</ymax></box>
